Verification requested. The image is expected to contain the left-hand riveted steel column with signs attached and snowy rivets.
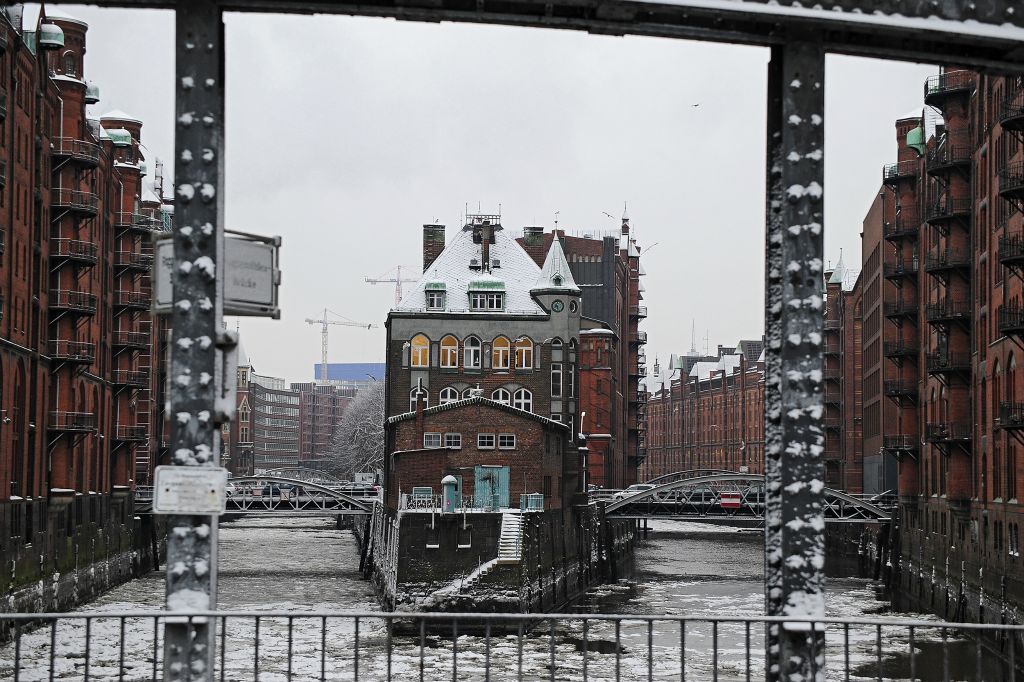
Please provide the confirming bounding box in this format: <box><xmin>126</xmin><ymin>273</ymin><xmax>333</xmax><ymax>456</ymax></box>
<box><xmin>164</xmin><ymin>0</ymin><xmax>224</xmax><ymax>682</ymax></box>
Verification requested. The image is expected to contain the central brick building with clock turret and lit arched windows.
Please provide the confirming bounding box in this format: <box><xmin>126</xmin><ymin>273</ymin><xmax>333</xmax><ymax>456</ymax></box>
<box><xmin>385</xmin><ymin>215</ymin><xmax>583</xmax><ymax>502</ymax></box>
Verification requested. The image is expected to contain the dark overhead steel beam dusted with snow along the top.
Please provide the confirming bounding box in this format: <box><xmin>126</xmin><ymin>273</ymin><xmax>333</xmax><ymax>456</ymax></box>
<box><xmin>75</xmin><ymin>0</ymin><xmax>1024</xmax><ymax>72</ymax></box>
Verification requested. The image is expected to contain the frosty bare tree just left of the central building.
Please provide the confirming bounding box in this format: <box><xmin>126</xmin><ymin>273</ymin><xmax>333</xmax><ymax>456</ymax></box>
<box><xmin>328</xmin><ymin>381</ymin><xmax>384</xmax><ymax>479</ymax></box>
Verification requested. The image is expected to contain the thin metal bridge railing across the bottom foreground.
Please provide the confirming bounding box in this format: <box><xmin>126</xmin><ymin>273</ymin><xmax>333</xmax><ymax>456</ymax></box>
<box><xmin>0</xmin><ymin>611</ymin><xmax>1024</xmax><ymax>681</ymax></box>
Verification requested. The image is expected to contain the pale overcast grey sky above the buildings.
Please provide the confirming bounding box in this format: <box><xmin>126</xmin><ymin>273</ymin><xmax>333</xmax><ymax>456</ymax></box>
<box><xmin>59</xmin><ymin>6</ymin><xmax>936</xmax><ymax>381</ymax></box>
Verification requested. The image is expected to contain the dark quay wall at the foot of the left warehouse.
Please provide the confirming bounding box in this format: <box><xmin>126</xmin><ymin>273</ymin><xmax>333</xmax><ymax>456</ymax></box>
<box><xmin>0</xmin><ymin>491</ymin><xmax>165</xmax><ymax>626</ymax></box>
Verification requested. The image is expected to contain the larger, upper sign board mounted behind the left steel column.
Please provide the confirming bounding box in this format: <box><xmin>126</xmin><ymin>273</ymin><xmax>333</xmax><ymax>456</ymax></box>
<box><xmin>153</xmin><ymin>225</ymin><xmax>281</xmax><ymax>319</ymax></box>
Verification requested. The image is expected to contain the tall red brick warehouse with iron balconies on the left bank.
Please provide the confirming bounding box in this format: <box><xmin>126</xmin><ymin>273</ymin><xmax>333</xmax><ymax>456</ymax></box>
<box><xmin>0</xmin><ymin>6</ymin><xmax>171</xmax><ymax>609</ymax></box>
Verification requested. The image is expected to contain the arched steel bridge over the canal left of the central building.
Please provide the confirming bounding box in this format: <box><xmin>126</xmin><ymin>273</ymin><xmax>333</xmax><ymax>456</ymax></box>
<box><xmin>135</xmin><ymin>475</ymin><xmax>378</xmax><ymax>516</ymax></box>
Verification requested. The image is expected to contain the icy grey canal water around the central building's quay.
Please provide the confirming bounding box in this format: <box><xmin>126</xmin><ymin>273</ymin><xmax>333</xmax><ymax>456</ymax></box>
<box><xmin>0</xmin><ymin>518</ymin><xmax>994</xmax><ymax>682</ymax></box>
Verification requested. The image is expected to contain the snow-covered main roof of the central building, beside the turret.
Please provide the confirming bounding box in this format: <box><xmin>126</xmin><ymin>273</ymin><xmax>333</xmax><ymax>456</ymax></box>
<box><xmin>394</xmin><ymin>227</ymin><xmax>547</xmax><ymax>315</ymax></box>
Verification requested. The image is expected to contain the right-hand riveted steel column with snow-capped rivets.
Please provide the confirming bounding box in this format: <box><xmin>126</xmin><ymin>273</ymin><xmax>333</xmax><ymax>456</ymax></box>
<box><xmin>765</xmin><ymin>37</ymin><xmax>824</xmax><ymax>682</ymax></box>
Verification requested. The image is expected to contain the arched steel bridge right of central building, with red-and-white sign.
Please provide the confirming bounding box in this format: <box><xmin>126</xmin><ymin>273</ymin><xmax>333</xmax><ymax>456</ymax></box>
<box><xmin>604</xmin><ymin>469</ymin><xmax>892</xmax><ymax>526</ymax></box>
